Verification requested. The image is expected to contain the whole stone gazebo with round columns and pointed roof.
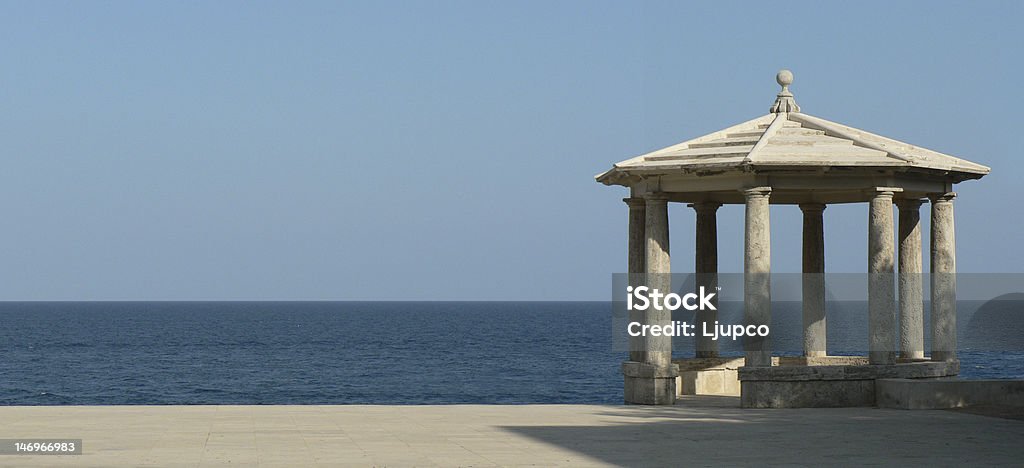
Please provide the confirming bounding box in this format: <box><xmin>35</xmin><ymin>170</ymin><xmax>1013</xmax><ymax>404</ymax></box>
<box><xmin>596</xmin><ymin>70</ymin><xmax>989</xmax><ymax>408</ymax></box>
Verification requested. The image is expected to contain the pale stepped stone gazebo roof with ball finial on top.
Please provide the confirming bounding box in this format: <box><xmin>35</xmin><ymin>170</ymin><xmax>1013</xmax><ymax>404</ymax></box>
<box><xmin>596</xmin><ymin>71</ymin><xmax>989</xmax><ymax>192</ymax></box>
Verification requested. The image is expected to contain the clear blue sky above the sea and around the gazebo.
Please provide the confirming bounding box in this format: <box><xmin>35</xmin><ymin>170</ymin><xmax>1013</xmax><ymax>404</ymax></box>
<box><xmin>0</xmin><ymin>1</ymin><xmax>1024</xmax><ymax>300</ymax></box>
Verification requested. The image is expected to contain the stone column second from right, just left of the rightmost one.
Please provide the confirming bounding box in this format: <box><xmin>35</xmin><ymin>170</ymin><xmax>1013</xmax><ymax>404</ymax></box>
<box><xmin>896</xmin><ymin>199</ymin><xmax>925</xmax><ymax>359</ymax></box>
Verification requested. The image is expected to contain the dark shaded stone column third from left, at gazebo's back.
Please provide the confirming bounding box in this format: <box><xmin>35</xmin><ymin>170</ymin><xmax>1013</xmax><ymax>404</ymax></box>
<box><xmin>690</xmin><ymin>202</ymin><xmax>722</xmax><ymax>357</ymax></box>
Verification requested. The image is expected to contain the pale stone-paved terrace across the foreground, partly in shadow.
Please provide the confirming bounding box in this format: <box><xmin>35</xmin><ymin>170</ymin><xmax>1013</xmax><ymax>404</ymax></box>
<box><xmin>0</xmin><ymin>397</ymin><xmax>1024</xmax><ymax>467</ymax></box>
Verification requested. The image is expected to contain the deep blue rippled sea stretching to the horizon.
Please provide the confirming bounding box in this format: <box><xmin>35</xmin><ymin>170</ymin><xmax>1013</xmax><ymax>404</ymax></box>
<box><xmin>0</xmin><ymin>302</ymin><xmax>1024</xmax><ymax>405</ymax></box>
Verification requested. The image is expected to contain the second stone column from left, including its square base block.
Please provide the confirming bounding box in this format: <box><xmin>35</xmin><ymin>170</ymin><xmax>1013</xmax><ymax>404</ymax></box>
<box><xmin>623</xmin><ymin>194</ymin><xmax>679</xmax><ymax>405</ymax></box>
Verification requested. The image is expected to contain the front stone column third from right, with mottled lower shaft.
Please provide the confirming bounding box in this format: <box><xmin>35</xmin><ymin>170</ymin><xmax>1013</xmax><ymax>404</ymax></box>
<box><xmin>867</xmin><ymin>188</ymin><xmax>896</xmax><ymax>365</ymax></box>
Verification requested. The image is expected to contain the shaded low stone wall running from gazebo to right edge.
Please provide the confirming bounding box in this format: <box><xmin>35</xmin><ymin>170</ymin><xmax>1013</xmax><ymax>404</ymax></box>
<box><xmin>874</xmin><ymin>379</ymin><xmax>1024</xmax><ymax>410</ymax></box>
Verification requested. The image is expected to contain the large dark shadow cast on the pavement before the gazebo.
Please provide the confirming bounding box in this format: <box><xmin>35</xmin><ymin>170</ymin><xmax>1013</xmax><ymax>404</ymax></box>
<box><xmin>502</xmin><ymin>396</ymin><xmax>1024</xmax><ymax>466</ymax></box>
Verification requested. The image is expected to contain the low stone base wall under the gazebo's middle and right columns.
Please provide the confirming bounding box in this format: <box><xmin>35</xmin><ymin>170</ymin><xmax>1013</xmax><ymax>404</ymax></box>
<box><xmin>737</xmin><ymin>360</ymin><xmax>959</xmax><ymax>408</ymax></box>
